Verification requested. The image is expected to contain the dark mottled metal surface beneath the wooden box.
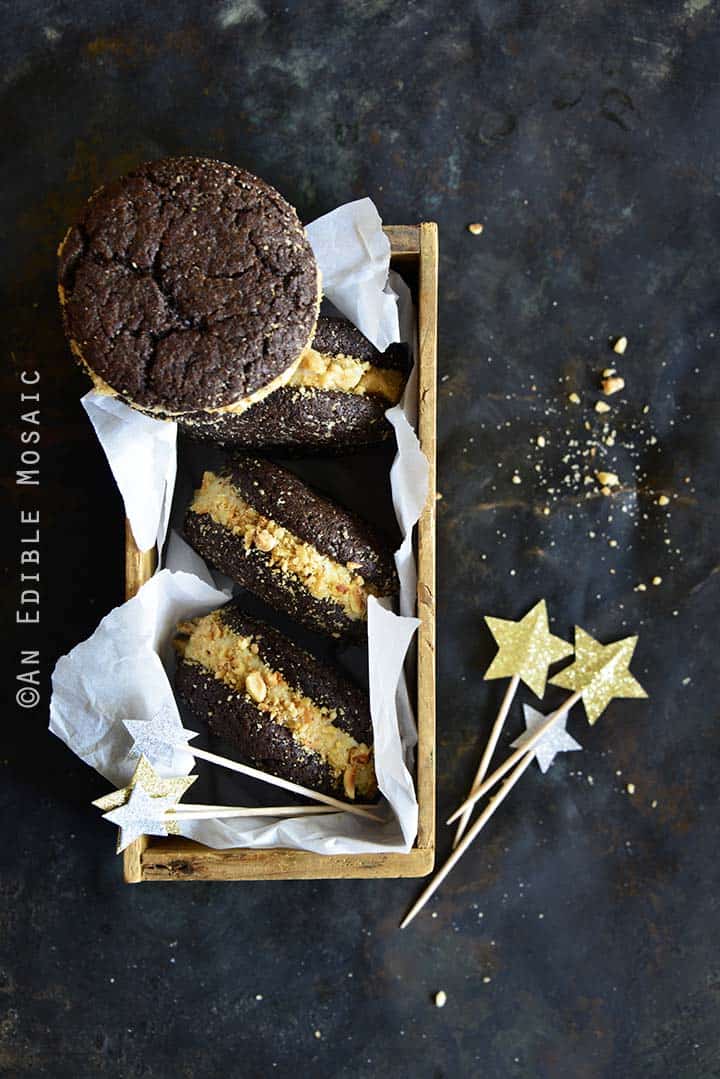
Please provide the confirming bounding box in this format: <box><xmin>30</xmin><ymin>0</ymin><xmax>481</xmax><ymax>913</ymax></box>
<box><xmin>0</xmin><ymin>0</ymin><xmax>720</xmax><ymax>1079</ymax></box>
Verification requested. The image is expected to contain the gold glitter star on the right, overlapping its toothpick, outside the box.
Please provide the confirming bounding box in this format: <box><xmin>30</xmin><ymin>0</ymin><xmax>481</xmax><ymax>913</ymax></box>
<box><xmin>551</xmin><ymin>626</ymin><xmax>648</xmax><ymax>723</ymax></box>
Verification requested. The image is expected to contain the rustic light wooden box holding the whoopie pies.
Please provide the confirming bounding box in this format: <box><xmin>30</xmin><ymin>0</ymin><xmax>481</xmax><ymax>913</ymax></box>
<box><xmin>124</xmin><ymin>222</ymin><xmax>437</xmax><ymax>884</ymax></box>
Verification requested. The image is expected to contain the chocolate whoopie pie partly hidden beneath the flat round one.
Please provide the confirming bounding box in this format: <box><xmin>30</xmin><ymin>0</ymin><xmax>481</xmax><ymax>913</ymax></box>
<box><xmin>178</xmin><ymin>316</ymin><xmax>410</xmax><ymax>452</ymax></box>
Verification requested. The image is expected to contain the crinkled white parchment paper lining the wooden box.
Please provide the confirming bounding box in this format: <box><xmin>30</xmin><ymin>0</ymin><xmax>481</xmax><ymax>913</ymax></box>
<box><xmin>50</xmin><ymin>199</ymin><xmax>427</xmax><ymax>853</ymax></box>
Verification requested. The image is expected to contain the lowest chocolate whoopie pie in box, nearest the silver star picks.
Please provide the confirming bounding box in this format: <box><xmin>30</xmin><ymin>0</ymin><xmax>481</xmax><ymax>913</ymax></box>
<box><xmin>175</xmin><ymin>603</ymin><xmax>377</xmax><ymax>802</ymax></box>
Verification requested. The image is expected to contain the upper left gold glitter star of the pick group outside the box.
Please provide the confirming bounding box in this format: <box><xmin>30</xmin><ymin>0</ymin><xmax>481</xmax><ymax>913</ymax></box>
<box><xmin>485</xmin><ymin>600</ymin><xmax>572</xmax><ymax>697</ymax></box>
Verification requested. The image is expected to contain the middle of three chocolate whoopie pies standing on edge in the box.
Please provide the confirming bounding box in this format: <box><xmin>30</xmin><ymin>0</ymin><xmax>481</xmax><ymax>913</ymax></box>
<box><xmin>184</xmin><ymin>455</ymin><xmax>398</xmax><ymax>640</ymax></box>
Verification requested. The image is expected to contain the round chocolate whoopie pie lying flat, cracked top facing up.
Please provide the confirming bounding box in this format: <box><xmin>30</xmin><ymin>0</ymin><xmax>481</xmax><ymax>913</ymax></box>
<box><xmin>53</xmin><ymin>158</ymin><xmax>320</xmax><ymax>416</ymax></box>
